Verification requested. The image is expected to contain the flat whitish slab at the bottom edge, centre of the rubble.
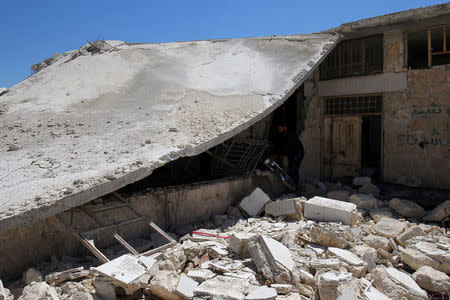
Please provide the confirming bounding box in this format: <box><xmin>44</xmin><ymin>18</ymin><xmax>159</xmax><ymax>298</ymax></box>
<box><xmin>194</xmin><ymin>276</ymin><xmax>257</xmax><ymax>300</ymax></box>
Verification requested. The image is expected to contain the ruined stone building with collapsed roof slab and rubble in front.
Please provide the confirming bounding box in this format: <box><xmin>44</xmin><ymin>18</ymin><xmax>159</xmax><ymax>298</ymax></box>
<box><xmin>0</xmin><ymin>4</ymin><xmax>450</xmax><ymax>299</ymax></box>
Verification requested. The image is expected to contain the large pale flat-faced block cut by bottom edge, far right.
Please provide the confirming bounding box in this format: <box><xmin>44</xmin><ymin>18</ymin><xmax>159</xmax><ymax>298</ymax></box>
<box><xmin>373</xmin><ymin>266</ymin><xmax>428</xmax><ymax>300</ymax></box>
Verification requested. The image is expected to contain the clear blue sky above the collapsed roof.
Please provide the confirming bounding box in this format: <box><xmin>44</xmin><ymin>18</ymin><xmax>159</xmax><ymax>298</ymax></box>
<box><xmin>0</xmin><ymin>0</ymin><xmax>446</xmax><ymax>87</ymax></box>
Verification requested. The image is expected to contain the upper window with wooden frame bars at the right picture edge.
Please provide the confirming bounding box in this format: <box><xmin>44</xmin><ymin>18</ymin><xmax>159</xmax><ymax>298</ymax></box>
<box><xmin>407</xmin><ymin>25</ymin><xmax>450</xmax><ymax>69</ymax></box>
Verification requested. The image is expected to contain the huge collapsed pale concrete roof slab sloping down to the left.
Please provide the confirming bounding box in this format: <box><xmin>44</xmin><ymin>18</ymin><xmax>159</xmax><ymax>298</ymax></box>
<box><xmin>0</xmin><ymin>33</ymin><xmax>339</xmax><ymax>234</ymax></box>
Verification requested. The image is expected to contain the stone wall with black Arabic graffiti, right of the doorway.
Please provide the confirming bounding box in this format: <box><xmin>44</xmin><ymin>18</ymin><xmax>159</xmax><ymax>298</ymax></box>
<box><xmin>384</xmin><ymin>65</ymin><xmax>450</xmax><ymax>188</ymax></box>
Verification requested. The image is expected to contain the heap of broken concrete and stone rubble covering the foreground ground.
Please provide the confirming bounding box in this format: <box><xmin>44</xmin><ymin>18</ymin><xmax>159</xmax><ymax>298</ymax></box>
<box><xmin>0</xmin><ymin>178</ymin><xmax>450</xmax><ymax>300</ymax></box>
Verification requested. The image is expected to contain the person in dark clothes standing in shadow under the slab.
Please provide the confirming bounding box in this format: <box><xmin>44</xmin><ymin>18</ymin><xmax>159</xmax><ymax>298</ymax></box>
<box><xmin>273</xmin><ymin>124</ymin><xmax>305</xmax><ymax>187</ymax></box>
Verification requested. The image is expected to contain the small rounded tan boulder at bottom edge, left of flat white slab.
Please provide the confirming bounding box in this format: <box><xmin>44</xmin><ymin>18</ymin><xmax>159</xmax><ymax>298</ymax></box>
<box><xmin>148</xmin><ymin>270</ymin><xmax>181</xmax><ymax>300</ymax></box>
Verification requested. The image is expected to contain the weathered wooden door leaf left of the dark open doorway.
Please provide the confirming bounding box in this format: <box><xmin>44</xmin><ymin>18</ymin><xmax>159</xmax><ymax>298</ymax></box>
<box><xmin>323</xmin><ymin>116</ymin><xmax>361</xmax><ymax>177</ymax></box>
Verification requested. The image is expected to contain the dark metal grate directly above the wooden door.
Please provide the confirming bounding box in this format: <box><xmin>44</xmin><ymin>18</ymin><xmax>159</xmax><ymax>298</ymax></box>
<box><xmin>325</xmin><ymin>95</ymin><xmax>382</xmax><ymax>115</ymax></box>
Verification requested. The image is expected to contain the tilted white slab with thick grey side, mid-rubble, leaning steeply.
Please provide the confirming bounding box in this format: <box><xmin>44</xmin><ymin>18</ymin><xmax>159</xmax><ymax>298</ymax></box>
<box><xmin>248</xmin><ymin>235</ymin><xmax>294</xmax><ymax>283</ymax></box>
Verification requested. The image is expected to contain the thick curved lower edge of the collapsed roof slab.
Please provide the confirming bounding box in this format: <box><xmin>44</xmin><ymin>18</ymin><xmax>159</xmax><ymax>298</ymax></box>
<box><xmin>0</xmin><ymin>34</ymin><xmax>342</xmax><ymax>235</ymax></box>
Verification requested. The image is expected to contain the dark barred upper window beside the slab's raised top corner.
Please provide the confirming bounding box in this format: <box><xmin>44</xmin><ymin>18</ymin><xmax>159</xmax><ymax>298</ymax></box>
<box><xmin>320</xmin><ymin>34</ymin><xmax>383</xmax><ymax>80</ymax></box>
